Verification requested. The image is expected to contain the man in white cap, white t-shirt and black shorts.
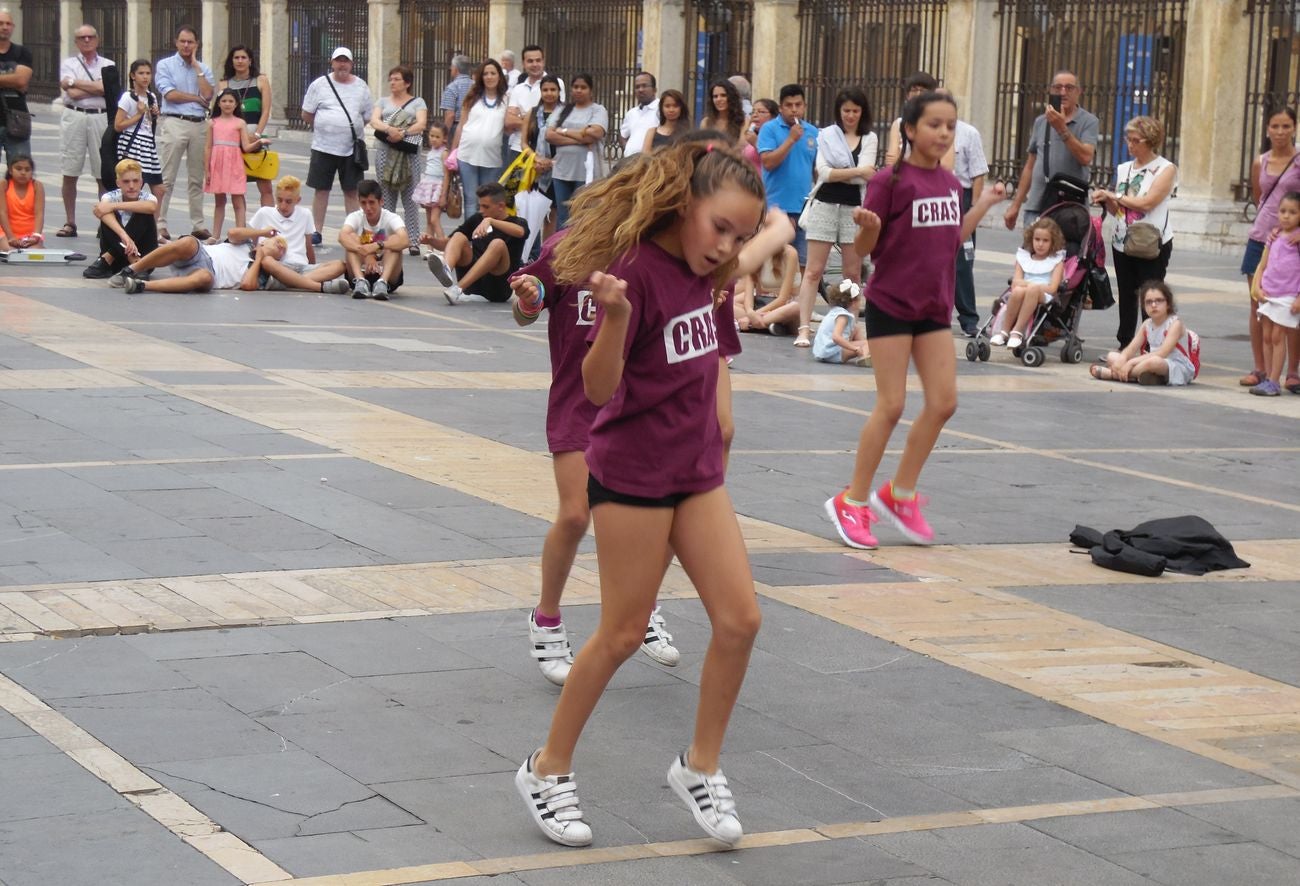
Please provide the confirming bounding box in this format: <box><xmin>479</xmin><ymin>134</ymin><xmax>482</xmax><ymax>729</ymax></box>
<box><xmin>303</xmin><ymin>47</ymin><xmax>374</xmax><ymax>244</ymax></box>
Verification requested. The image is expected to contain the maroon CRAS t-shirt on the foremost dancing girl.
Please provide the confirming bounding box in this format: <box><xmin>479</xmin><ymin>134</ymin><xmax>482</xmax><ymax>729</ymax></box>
<box><xmin>586</xmin><ymin>240</ymin><xmax>732</xmax><ymax>499</ymax></box>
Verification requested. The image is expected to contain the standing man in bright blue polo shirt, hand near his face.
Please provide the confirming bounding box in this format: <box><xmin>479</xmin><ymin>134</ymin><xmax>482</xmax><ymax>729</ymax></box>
<box><xmin>758</xmin><ymin>83</ymin><xmax>816</xmax><ymax>268</ymax></box>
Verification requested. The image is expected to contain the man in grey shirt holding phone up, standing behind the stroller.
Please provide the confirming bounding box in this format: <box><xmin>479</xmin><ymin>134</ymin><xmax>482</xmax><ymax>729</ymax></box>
<box><xmin>1002</xmin><ymin>70</ymin><xmax>1099</xmax><ymax>230</ymax></box>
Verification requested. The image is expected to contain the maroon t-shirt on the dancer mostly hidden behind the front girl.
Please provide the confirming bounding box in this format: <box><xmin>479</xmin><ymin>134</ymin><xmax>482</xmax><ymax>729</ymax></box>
<box><xmin>519</xmin><ymin>231</ymin><xmax>597</xmax><ymax>452</ymax></box>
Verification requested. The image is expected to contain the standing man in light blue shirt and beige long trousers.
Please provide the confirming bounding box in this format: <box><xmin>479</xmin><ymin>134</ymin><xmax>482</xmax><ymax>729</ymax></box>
<box><xmin>153</xmin><ymin>25</ymin><xmax>217</xmax><ymax>240</ymax></box>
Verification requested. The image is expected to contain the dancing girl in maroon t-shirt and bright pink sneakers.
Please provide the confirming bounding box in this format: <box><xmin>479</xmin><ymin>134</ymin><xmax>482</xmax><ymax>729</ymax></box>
<box><xmin>826</xmin><ymin>92</ymin><xmax>1006</xmax><ymax>548</ymax></box>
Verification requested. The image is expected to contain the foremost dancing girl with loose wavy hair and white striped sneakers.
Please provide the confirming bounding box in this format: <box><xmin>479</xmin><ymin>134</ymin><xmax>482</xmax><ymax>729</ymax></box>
<box><xmin>515</xmin><ymin>143</ymin><xmax>793</xmax><ymax>846</ymax></box>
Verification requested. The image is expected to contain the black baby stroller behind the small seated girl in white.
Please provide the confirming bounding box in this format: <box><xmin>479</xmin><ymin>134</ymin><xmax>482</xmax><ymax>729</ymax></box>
<box><xmin>966</xmin><ymin>175</ymin><xmax>1106</xmax><ymax>366</ymax></box>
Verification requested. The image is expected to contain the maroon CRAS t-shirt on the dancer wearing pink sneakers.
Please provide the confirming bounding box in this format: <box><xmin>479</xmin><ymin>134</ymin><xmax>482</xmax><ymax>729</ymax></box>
<box><xmin>863</xmin><ymin>162</ymin><xmax>962</xmax><ymax>326</ymax></box>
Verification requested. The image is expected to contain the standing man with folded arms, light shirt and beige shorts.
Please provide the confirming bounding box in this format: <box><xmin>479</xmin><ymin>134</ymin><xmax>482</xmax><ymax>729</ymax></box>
<box><xmin>56</xmin><ymin>25</ymin><xmax>117</xmax><ymax>236</ymax></box>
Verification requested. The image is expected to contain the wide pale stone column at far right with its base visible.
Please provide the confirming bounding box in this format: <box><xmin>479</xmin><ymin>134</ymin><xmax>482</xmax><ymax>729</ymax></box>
<box><xmin>1169</xmin><ymin>0</ymin><xmax>1258</xmax><ymax>252</ymax></box>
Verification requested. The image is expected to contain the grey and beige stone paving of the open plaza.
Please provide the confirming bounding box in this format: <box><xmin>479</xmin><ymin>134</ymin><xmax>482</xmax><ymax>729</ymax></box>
<box><xmin>0</xmin><ymin>118</ymin><xmax>1300</xmax><ymax>886</ymax></box>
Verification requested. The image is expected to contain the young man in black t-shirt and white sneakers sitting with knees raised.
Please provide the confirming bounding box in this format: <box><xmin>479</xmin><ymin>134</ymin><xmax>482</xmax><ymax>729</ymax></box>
<box><xmin>420</xmin><ymin>182</ymin><xmax>528</xmax><ymax>304</ymax></box>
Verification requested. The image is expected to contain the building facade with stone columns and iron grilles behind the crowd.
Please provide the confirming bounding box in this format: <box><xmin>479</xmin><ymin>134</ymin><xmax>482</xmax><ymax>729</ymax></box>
<box><xmin>12</xmin><ymin>0</ymin><xmax>1300</xmax><ymax>249</ymax></box>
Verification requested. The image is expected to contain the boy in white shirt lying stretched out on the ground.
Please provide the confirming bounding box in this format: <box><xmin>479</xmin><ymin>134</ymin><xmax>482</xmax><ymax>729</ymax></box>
<box><xmin>115</xmin><ymin>235</ymin><xmax>347</xmax><ymax>295</ymax></box>
